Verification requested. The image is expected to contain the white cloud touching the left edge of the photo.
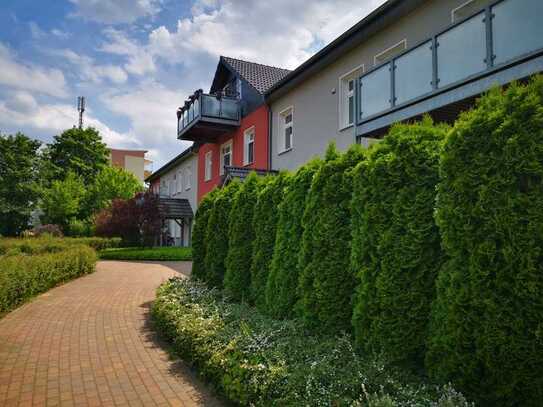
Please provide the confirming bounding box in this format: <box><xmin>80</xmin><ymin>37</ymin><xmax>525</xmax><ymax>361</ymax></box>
<box><xmin>0</xmin><ymin>43</ymin><xmax>68</xmax><ymax>97</ymax></box>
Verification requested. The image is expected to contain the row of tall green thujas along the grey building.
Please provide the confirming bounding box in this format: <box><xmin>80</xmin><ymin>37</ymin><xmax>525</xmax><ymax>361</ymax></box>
<box><xmin>187</xmin><ymin>77</ymin><xmax>543</xmax><ymax>406</ymax></box>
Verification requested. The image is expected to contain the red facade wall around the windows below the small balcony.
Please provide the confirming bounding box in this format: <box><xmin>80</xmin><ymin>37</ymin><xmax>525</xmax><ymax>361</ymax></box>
<box><xmin>198</xmin><ymin>105</ymin><xmax>268</xmax><ymax>202</ymax></box>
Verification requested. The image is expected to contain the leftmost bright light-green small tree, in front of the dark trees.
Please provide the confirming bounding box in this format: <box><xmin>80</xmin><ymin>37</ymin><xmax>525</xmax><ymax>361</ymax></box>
<box><xmin>40</xmin><ymin>172</ymin><xmax>86</xmax><ymax>232</ymax></box>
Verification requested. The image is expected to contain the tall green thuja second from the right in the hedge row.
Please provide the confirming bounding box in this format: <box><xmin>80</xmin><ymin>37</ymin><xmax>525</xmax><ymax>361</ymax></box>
<box><xmin>352</xmin><ymin>118</ymin><xmax>447</xmax><ymax>367</ymax></box>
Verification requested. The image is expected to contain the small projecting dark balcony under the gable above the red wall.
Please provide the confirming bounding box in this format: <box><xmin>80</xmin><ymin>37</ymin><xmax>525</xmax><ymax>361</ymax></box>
<box><xmin>177</xmin><ymin>90</ymin><xmax>240</xmax><ymax>144</ymax></box>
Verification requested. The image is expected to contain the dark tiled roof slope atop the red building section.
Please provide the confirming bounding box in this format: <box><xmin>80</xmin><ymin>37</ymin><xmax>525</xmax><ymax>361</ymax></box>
<box><xmin>221</xmin><ymin>57</ymin><xmax>290</xmax><ymax>94</ymax></box>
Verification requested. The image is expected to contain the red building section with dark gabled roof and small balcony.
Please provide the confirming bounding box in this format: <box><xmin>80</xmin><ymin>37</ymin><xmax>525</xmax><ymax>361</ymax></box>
<box><xmin>178</xmin><ymin>57</ymin><xmax>290</xmax><ymax>201</ymax></box>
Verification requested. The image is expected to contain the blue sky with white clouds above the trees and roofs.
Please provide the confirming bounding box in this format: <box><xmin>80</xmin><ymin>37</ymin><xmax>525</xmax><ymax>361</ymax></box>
<box><xmin>0</xmin><ymin>0</ymin><xmax>383</xmax><ymax>169</ymax></box>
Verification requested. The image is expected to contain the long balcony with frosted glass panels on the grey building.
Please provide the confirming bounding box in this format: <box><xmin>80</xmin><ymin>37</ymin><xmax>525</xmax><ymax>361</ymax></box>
<box><xmin>356</xmin><ymin>0</ymin><xmax>543</xmax><ymax>136</ymax></box>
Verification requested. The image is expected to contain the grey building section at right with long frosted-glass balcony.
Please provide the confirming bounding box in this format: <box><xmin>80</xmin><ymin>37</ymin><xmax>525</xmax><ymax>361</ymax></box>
<box><xmin>266</xmin><ymin>0</ymin><xmax>543</xmax><ymax>170</ymax></box>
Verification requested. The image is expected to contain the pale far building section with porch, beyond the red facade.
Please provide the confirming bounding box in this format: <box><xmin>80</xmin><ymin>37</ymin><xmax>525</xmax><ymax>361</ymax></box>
<box><xmin>145</xmin><ymin>147</ymin><xmax>198</xmax><ymax>247</ymax></box>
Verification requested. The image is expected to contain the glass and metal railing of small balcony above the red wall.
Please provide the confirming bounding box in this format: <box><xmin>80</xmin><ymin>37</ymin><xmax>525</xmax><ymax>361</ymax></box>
<box><xmin>178</xmin><ymin>92</ymin><xmax>240</xmax><ymax>134</ymax></box>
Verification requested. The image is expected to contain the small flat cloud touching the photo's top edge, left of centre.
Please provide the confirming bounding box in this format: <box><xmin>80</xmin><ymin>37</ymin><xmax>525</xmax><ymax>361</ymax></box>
<box><xmin>70</xmin><ymin>0</ymin><xmax>161</xmax><ymax>24</ymax></box>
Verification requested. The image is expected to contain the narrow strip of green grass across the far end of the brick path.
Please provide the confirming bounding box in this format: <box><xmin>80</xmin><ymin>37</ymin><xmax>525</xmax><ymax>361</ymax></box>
<box><xmin>98</xmin><ymin>247</ymin><xmax>192</xmax><ymax>261</ymax></box>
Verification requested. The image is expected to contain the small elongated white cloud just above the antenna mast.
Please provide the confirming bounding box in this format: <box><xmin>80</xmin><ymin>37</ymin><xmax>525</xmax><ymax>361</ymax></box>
<box><xmin>47</xmin><ymin>49</ymin><xmax>128</xmax><ymax>84</ymax></box>
